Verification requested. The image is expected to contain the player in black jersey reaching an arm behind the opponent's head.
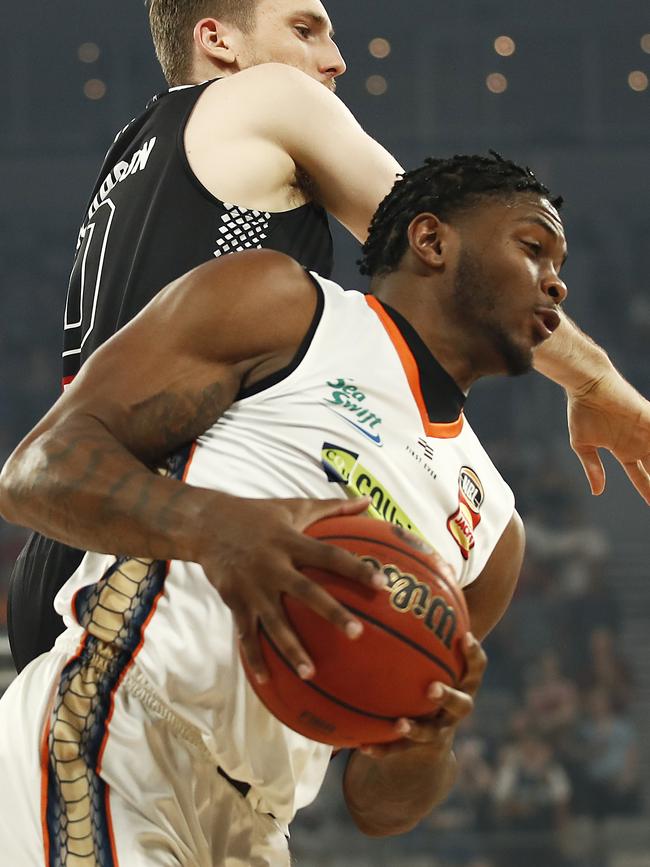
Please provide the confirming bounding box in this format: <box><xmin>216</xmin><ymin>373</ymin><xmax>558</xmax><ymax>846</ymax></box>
<box><xmin>8</xmin><ymin>0</ymin><xmax>650</xmax><ymax>669</ymax></box>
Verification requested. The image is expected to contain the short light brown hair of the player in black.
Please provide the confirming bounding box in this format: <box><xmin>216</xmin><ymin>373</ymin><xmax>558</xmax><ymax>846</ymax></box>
<box><xmin>145</xmin><ymin>0</ymin><xmax>257</xmax><ymax>87</ymax></box>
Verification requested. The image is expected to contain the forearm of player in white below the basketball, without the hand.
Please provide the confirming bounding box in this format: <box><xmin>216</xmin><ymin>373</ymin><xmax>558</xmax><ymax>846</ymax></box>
<box><xmin>343</xmin><ymin>739</ymin><xmax>456</xmax><ymax>837</ymax></box>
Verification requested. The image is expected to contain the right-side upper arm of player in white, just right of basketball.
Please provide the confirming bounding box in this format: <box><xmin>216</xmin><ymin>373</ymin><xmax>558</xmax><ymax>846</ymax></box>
<box><xmin>464</xmin><ymin>512</ymin><xmax>525</xmax><ymax>641</ymax></box>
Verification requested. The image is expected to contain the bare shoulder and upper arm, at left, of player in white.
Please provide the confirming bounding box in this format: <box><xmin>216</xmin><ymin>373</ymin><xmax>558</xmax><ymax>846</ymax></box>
<box><xmin>28</xmin><ymin>251</ymin><xmax>315</xmax><ymax>462</ymax></box>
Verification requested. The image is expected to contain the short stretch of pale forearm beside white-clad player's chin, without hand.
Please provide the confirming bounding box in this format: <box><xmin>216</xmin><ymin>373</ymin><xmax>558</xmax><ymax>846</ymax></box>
<box><xmin>534</xmin><ymin>313</ymin><xmax>614</xmax><ymax>394</ymax></box>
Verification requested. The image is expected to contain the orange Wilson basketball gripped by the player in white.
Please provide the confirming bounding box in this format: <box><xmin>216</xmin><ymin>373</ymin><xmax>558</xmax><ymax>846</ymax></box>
<box><xmin>240</xmin><ymin>516</ymin><xmax>469</xmax><ymax>747</ymax></box>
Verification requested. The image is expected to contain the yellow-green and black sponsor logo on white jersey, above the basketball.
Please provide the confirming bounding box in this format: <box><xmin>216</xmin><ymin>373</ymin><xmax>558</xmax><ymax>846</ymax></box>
<box><xmin>321</xmin><ymin>443</ymin><xmax>428</xmax><ymax>542</ymax></box>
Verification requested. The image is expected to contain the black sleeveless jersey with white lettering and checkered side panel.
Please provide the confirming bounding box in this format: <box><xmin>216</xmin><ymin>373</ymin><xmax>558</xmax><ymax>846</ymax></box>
<box><xmin>8</xmin><ymin>82</ymin><xmax>332</xmax><ymax>670</ymax></box>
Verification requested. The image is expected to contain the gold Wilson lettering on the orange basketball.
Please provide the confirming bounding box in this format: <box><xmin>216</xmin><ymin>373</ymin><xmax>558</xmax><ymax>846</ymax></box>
<box><xmin>361</xmin><ymin>557</ymin><xmax>457</xmax><ymax>647</ymax></box>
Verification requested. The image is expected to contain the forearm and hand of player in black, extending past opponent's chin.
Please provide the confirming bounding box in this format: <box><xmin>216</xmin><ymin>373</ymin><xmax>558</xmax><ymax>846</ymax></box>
<box><xmin>535</xmin><ymin>315</ymin><xmax>650</xmax><ymax>505</ymax></box>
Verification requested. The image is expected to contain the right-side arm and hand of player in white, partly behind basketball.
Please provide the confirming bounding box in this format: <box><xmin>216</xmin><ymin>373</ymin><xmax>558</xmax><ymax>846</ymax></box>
<box><xmin>343</xmin><ymin>512</ymin><xmax>524</xmax><ymax>836</ymax></box>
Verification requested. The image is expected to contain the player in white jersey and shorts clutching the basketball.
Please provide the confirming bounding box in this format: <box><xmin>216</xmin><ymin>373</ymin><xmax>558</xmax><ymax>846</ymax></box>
<box><xmin>0</xmin><ymin>156</ymin><xmax>566</xmax><ymax>867</ymax></box>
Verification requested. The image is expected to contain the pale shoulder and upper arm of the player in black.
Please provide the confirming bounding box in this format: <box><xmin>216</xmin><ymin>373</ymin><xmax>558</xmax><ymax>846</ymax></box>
<box><xmin>186</xmin><ymin>63</ymin><xmax>402</xmax><ymax>242</ymax></box>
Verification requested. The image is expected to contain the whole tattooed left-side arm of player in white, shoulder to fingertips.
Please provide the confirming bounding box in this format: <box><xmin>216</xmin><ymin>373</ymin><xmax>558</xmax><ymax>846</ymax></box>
<box><xmin>0</xmin><ymin>251</ymin><xmax>380</xmax><ymax>678</ymax></box>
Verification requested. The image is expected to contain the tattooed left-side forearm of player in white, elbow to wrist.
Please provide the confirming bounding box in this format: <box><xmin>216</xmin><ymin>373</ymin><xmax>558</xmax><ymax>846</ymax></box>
<box><xmin>0</xmin><ymin>416</ymin><xmax>219</xmax><ymax>560</ymax></box>
